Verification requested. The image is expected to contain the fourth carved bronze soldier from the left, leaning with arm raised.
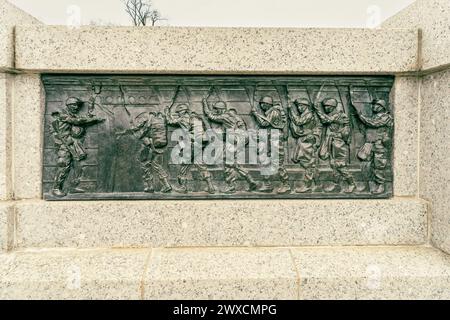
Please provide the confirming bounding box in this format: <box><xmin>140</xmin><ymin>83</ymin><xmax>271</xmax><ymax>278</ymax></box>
<box><xmin>203</xmin><ymin>99</ymin><xmax>258</xmax><ymax>193</ymax></box>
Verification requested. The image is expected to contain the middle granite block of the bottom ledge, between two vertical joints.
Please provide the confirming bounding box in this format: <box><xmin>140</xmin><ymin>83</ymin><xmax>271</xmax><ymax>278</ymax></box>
<box><xmin>144</xmin><ymin>248</ymin><xmax>297</xmax><ymax>300</ymax></box>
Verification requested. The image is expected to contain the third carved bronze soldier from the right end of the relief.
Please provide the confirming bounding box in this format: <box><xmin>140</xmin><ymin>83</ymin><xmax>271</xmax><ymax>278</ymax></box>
<box><xmin>288</xmin><ymin>98</ymin><xmax>322</xmax><ymax>193</ymax></box>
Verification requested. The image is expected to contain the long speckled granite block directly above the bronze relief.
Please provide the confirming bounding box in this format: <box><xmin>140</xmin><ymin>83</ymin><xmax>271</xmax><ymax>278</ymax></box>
<box><xmin>16</xmin><ymin>26</ymin><xmax>418</xmax><ymax>74</ymax></box>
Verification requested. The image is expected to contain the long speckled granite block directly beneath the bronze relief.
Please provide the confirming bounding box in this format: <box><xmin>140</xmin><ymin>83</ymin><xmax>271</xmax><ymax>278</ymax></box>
<box><xmin>16</xmin><ymin>198</ymin><xmax>427</xmax><ymax>248</ymax></box>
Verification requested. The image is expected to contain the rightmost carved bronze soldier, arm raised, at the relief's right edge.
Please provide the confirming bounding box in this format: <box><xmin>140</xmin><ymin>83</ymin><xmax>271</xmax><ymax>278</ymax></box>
<box><xmin>350</xmin><ymin>95</ymin><xmax>394</xmax><ymax>194</ymax></box>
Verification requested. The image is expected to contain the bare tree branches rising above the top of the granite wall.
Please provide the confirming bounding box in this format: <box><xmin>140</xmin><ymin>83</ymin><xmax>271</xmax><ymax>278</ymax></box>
<box><xmin>123</xmin><ymin>0</ymin><xmax>166</xmax><ymax>26</ymax></box>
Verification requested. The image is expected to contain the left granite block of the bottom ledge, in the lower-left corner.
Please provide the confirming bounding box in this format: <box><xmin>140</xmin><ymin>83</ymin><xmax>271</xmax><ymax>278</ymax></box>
<box><xmin>0</xmin><ymin>250</ymin><xmax>150</xmax><ymax>300</ymax></box>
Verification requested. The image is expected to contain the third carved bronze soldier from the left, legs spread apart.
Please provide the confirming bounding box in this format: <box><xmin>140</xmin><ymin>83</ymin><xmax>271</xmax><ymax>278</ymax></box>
<box><xmin>165</xmin><ymin>104</ymin><xmax>216</xmax><ymax>194</ymax></box>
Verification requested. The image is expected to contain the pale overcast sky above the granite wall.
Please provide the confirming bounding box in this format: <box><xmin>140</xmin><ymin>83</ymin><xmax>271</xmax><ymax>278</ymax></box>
<box><xmin>9</xmin><ymin>0</ymin><xmax>414</xmax><ymax>27</ymax></box>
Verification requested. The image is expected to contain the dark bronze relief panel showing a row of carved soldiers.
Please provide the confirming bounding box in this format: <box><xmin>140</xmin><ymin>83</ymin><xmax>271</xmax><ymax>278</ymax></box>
<box><xmin>43</xmin><ymin>75</ymin><xmax>394</xmax><ymax>200</ymax></box>
